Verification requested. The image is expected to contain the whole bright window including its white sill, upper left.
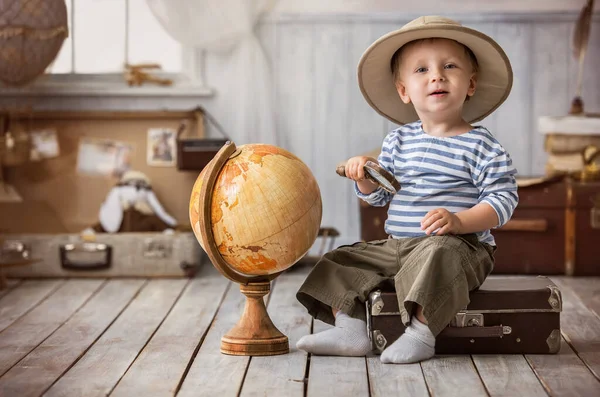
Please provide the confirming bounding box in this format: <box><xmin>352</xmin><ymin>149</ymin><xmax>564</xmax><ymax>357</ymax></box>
<box><xmin>0</xmin><ymin>0</ymin><xmax>214</xmax><ymax>98</ymax></box>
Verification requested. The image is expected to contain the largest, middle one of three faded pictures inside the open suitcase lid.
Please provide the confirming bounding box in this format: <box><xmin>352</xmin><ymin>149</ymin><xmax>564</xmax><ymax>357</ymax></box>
<box><xmin>77</xmin><ymin>138</ymin><xmax>133</xmax><ymax>177</ymax></box>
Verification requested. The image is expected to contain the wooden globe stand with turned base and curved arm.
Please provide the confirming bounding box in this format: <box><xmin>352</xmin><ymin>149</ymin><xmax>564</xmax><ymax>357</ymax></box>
<box><xmin>199</xmin><ymin>142</ymin><xmax>289</xmax><ymax>356</ymax></box>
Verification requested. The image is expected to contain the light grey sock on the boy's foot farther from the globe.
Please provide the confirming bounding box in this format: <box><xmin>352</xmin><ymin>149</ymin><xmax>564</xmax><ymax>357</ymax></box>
<box><xmin>381</xmin><ymin>317</ymin><xmax>435</xmax><ymax>364</ymax></box>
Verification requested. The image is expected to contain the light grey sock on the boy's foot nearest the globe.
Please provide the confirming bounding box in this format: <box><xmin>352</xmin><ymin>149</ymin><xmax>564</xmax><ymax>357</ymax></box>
<box><xmin>296</xmin><ymin>312</ymin><xmax>371</xmax><ymax>357</ymax></box>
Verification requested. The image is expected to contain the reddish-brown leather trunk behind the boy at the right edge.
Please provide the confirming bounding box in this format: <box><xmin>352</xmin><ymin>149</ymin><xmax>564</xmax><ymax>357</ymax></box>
<box><xmin>492</xmin><ymin>178</ymin><xmax>600</xmax><ymax>276</ymax></box>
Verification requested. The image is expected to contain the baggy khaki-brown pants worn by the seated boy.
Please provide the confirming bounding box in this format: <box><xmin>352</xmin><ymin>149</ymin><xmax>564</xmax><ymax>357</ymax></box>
<box><xmin>296</xmin><ymin>234</ymin><xmax>495</xmax><ymax>335</ymax></box>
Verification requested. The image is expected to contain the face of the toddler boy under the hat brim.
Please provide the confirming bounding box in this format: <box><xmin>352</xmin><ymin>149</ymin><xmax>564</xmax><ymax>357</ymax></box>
<box><xmin>396</xmin><ymin>39</ymin><xmax>477</xmax><ymax>120</ymax></box>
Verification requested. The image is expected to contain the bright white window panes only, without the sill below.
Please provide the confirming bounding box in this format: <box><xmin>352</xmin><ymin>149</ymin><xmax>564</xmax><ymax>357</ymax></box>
<box><xmin>48</xmin><ymin>0</ymin><xmax>182</xmax><ymax>74</ymax></box>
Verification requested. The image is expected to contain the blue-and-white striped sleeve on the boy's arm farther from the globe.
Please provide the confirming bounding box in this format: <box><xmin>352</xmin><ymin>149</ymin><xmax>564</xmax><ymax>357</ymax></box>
<box><xmin>477</xmin><ymin>150</ymin><xmax>519</xmax><ymax>227</ymax></box>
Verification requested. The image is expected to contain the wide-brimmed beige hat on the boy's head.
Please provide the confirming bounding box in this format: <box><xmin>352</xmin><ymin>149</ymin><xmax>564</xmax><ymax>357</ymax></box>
<box><xmin>358</xmin><ymin>16</ymin><xmax>513</xmax><ymax>124</ymax></box>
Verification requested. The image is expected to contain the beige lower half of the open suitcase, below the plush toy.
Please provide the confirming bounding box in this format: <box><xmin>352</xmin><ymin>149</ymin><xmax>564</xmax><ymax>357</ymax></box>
<box><xmin>0</xmin><ymin>232</ymin><xmax>207</xmax><ymax>278</ymax></box>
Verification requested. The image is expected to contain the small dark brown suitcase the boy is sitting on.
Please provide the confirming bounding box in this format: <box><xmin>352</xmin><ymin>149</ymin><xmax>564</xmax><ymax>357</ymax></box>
<box><xmin>366</xmin><ymin>276</ymin><xmax>562</xmax><ymax>354</ymax></box>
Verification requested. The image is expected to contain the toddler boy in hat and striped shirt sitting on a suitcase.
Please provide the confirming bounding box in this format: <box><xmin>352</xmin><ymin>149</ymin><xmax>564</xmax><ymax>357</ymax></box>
<box><xmin>297</xmin><ymin>17</ymin><xmax>518</xmax><ymax>363</ymax></box>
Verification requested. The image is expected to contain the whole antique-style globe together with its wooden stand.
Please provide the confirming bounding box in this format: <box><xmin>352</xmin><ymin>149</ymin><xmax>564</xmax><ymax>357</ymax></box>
<box><xmin>189</xmin><ymin>142</ymin><xmax>322</xmax><ymax>355</ymax></box>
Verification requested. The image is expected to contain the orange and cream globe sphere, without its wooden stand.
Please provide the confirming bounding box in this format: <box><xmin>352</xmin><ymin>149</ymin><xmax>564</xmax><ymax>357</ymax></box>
<box><xmin>189</xmin><ymin>144</ymin><xmax>322</xmax><ymax>276</ymax></box>
